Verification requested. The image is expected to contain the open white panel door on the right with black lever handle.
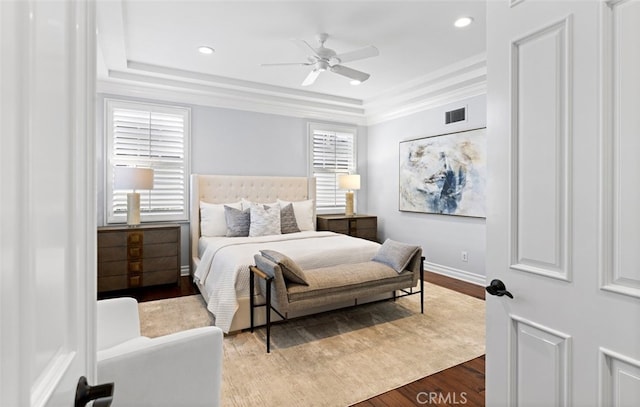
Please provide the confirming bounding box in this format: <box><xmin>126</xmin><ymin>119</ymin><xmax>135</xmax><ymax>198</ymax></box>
<box><xmin>486</xmin><ymin>0</ymin><xmax>640</xmax><ymax>407</ymax></box>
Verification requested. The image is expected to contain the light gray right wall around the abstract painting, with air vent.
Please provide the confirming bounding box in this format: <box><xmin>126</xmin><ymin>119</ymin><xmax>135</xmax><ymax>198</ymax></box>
<box><xmin>366</xmin><ymin>96</ymin><xmax>486</xmax><ymax>283</ymax></box>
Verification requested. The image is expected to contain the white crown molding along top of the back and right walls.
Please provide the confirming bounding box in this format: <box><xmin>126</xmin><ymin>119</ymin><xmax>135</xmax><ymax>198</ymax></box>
<box><xmin>96</xmin><ymin>54</ymin><xmax>487</xmax><ymax>125</ymax></box>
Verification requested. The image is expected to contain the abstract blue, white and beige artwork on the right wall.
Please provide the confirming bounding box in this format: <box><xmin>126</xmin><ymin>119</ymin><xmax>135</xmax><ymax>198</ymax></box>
<box><xmin>399</xmin><ymin>128</ymin><xmax>487</xmax><ymax>218</ymax></box>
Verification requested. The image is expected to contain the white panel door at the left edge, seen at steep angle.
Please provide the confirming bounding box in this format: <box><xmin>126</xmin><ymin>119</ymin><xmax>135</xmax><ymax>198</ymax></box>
<box><xmin>0</xmin><ymin>0</ymin><xmax>96</xmax><ymax>406</ymax></box>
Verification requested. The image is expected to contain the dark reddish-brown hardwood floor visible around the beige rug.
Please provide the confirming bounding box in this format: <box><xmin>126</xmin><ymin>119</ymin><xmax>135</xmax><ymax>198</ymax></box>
<box><xmin>98</xmin><ymin>272</ymin><xmax>485</xmax><ymax>407</ymax></box>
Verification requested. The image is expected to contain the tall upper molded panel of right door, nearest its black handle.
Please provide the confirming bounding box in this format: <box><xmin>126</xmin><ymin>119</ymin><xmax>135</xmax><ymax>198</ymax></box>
<box><xmin>511</xmin><ymin>17</ymin><xmax>573</xmax><ymax>280</ymax></box>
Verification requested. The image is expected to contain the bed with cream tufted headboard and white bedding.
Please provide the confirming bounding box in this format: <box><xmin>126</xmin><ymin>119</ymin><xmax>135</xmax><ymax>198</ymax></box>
<box><xmin>190</xmin><ymin>174</ymin><xmax>382</xmax><ymax>333</ymax></box>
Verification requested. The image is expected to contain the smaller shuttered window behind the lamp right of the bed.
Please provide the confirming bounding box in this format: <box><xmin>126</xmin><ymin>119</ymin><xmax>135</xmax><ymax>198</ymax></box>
<box><xmin>309</xmin><ymin>123</ymin><xmax>357</xmax><ymax>213</ymax></box>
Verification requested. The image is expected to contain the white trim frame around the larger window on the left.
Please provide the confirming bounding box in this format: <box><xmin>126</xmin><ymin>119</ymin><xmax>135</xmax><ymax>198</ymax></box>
<box><xmin>103</xmin><ymin>98</ymin><xmax>191</xmax><ymax>224</ymax></box>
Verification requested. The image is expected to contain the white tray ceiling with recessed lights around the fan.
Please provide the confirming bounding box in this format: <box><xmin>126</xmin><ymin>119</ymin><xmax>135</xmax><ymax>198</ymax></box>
<box><xmin>97</xmin><ymin>0</ymin><xmax>486</xmax><ymax>123</ymax></box>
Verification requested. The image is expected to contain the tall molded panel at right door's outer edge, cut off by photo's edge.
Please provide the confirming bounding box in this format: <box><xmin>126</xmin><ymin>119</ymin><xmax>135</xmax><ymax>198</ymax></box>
<box><xmin>600</xmin><ymin>1</ymin><xmax>640</xmax><ymax>298</ymax></box>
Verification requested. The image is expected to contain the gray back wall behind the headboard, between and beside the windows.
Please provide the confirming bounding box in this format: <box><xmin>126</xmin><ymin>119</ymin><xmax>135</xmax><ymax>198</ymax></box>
<box><xmin>96</xmin><ymin>94</ymin><xmax>367</xmax><ymax>269</ymax></box>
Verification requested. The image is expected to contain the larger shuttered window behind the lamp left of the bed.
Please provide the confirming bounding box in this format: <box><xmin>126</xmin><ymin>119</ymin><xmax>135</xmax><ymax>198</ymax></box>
<box><xmin>105</xmin><ymin>99</ymin><xmax>190</xmax><ymax>223</ymax></box>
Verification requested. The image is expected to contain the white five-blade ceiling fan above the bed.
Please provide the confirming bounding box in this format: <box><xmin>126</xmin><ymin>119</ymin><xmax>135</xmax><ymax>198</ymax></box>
<box><xmin>262</xmin><ymin>33</ymin><xmax>379</xmax><ymax>86</ymax></box>
